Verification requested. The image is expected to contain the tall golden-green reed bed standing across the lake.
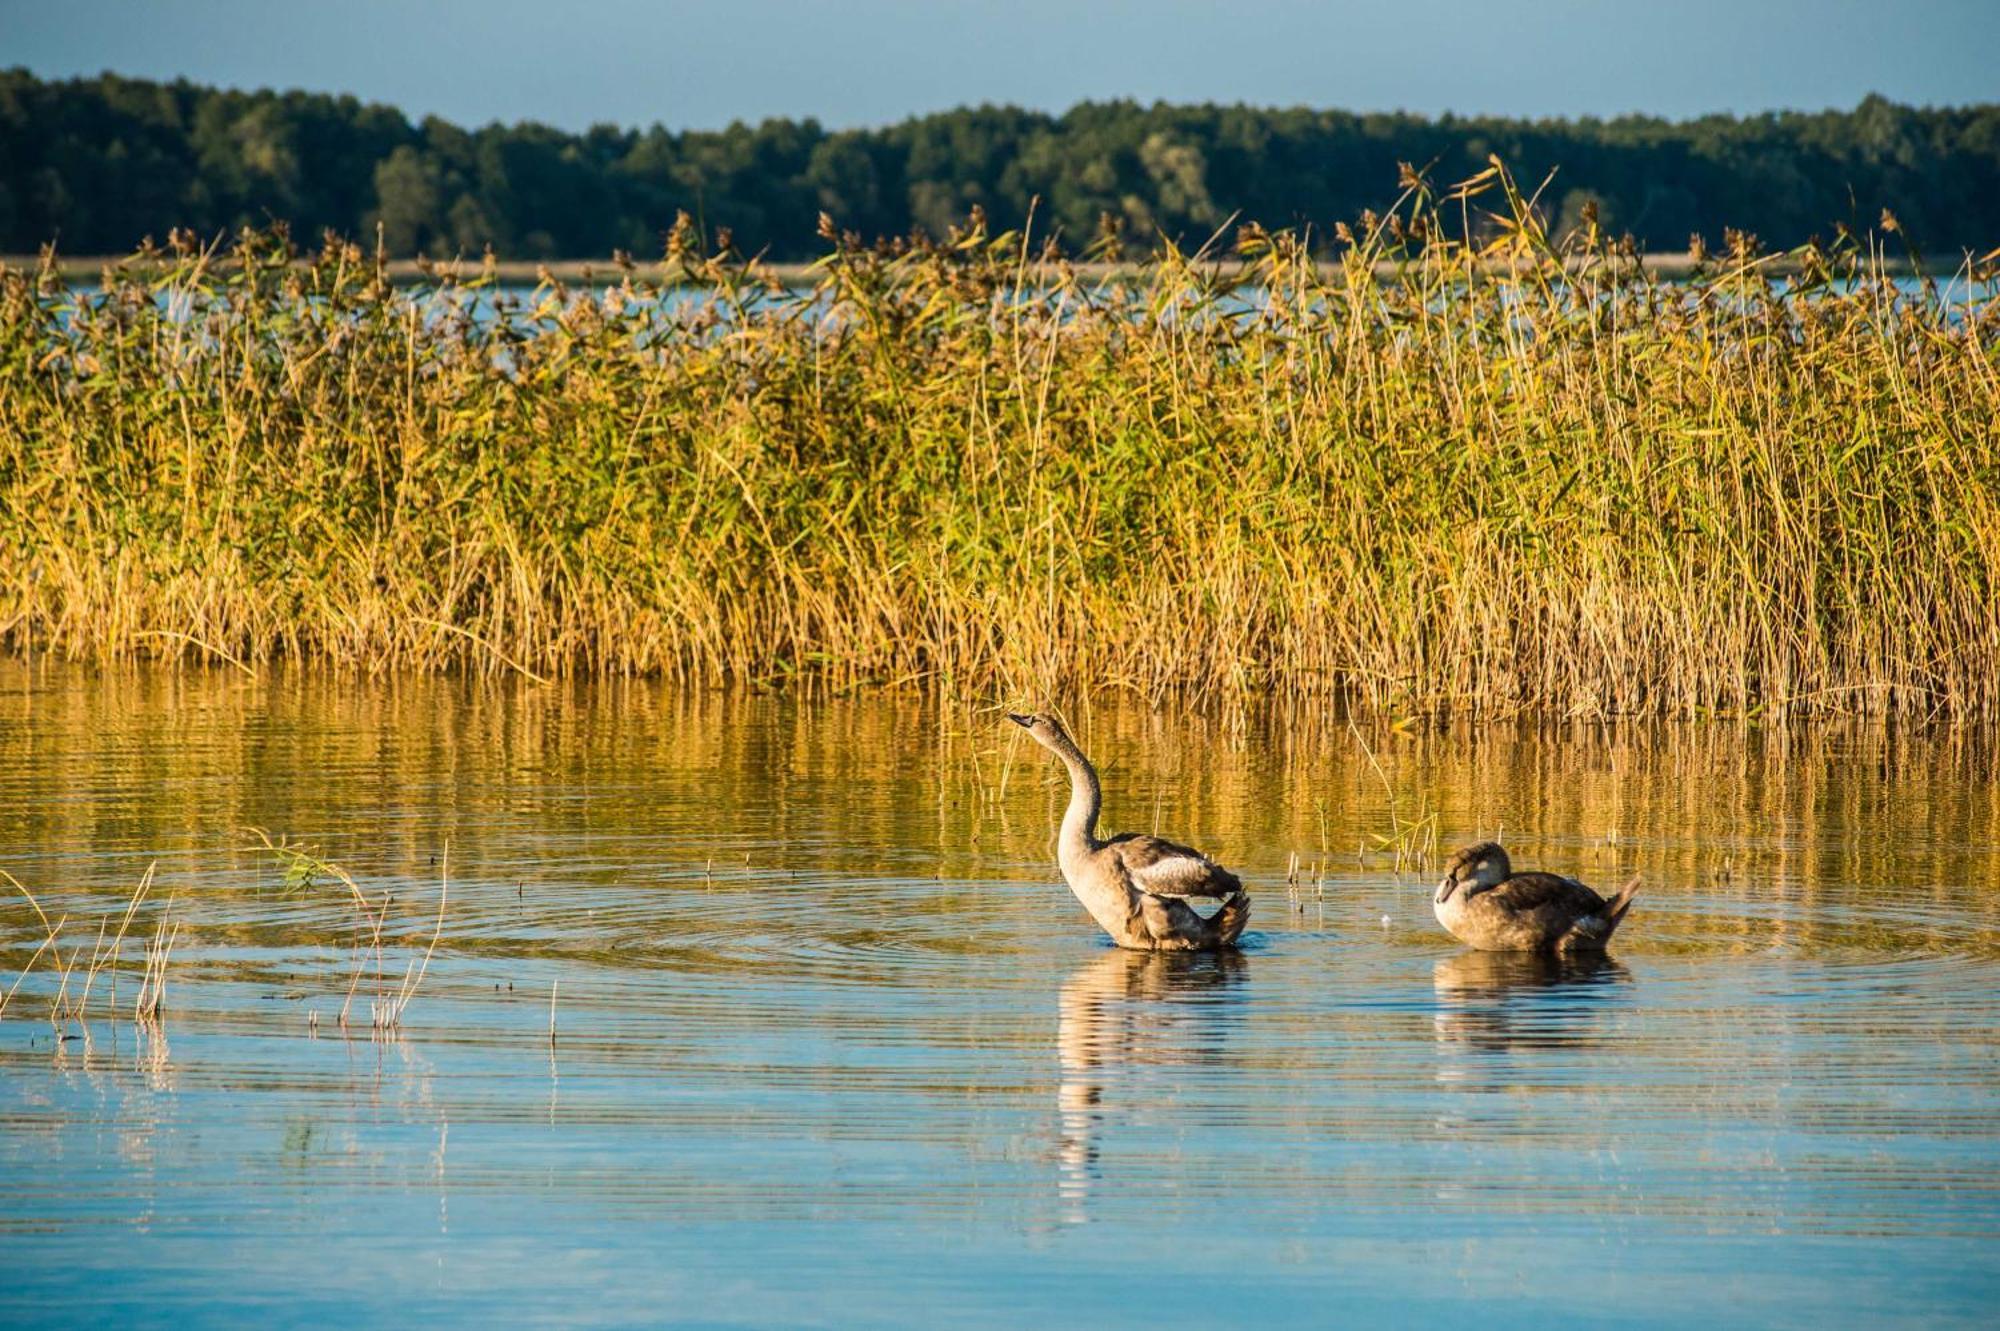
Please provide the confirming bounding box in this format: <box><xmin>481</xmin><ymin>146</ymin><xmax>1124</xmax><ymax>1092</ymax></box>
<box><xmin>0</xmin><ymin>164</ymin><xmax>2000</xmax><ymax>719</ymax></box>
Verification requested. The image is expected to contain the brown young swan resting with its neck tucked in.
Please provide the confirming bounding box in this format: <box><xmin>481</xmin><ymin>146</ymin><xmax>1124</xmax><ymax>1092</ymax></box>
<box><xmin>1432</xmin><ymin>841</ymin><xmax>1638</xmax><ymax>951</ymax></box>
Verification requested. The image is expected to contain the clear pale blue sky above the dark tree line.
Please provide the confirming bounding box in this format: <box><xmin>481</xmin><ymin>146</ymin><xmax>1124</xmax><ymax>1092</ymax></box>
<box><xmin>0</xmin><ymin>0</ymin><xmax>2000</xmax><ymax>130</ymax></box>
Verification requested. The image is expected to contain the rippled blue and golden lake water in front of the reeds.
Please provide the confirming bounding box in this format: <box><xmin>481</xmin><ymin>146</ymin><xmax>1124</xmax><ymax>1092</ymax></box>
<box><xmin>0</xmin><ymin>662</ymin><xmax>2000</xmax><ymax>1327</ymax></box>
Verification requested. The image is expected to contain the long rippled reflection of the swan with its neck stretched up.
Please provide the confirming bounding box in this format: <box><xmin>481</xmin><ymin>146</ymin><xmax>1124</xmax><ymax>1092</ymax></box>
<box><xmin>1056</xmin><ymin>947</ymin><xmax>1248</xmax><ymax>1223</ymax></box>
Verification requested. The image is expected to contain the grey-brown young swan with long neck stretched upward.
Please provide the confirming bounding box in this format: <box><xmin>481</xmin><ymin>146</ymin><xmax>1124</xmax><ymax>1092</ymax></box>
<box><xmin>1008</xmin><ymin>711</ymin><xmax>1250</xmax><ymax>951</ymax></box>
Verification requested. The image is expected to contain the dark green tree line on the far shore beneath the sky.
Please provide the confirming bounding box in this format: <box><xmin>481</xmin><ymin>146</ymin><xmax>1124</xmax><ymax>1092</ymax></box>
<box><xmin>0</xmin><ymin>70</ymin><xmax>2000</xmax><ymax>260</ymax></box>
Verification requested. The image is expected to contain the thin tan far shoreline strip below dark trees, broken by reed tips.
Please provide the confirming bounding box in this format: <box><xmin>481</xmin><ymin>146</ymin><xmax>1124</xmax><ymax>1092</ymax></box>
<box><xmin>0</xmin><ymin>250</ymin><xmax>1968</xmax><ymax>286</ymax></box>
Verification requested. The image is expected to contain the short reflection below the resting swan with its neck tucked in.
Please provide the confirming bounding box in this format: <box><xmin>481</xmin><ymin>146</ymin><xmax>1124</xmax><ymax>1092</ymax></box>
<box><xmin>1430</xmin><ymin>951</ymin><xmax>1632</xmax><ymax>1079</ymax></box>
